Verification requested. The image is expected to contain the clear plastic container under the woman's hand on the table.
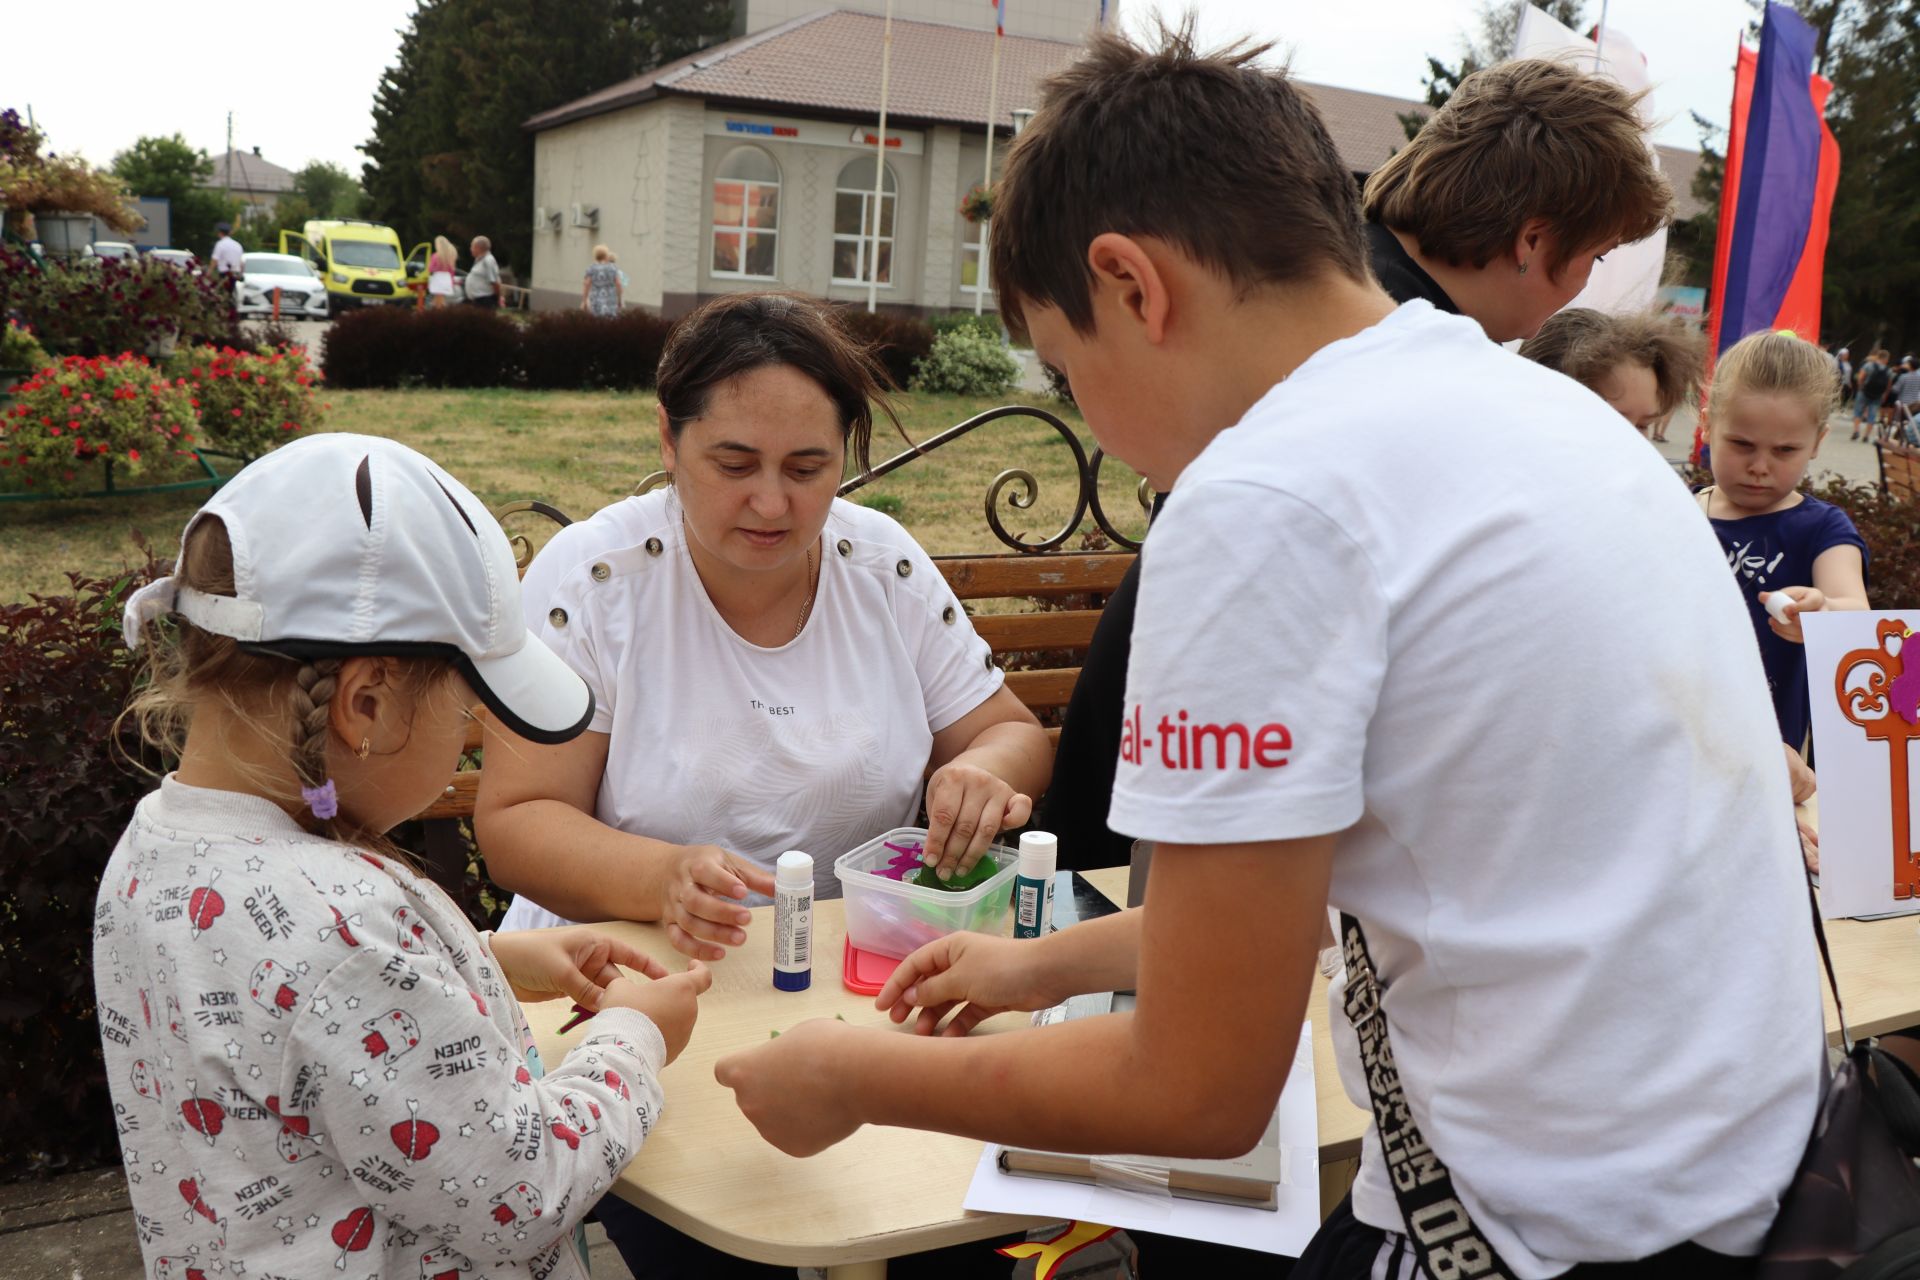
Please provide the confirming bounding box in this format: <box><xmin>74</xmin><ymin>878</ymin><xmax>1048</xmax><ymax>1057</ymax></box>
<box><xmin>833</xmin><ymin>827</ymin><xmax>1020</xmax><ymax>958</ymax></box>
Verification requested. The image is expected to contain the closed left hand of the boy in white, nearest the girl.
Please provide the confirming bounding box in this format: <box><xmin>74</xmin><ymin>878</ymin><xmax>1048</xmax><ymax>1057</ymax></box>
<box><xmin>714</xmin><ymin>1017</ymin><xmax>876</xmax><ymax>1155</ymax></box>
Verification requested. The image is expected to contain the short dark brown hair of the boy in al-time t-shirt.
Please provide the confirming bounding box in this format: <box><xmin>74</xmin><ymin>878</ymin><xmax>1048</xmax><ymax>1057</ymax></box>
<box><xmin>993</xmin><ymin>17</ymin><xmax>1367</xmax><ymax>332</ymax></box>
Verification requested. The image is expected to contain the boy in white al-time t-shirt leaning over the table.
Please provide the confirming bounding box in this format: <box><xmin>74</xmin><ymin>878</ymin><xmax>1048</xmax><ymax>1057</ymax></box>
<box><xmin>716</xmin><ymin>22</ymin><xmax>1824</xmax><ymax>1280</ymax></box>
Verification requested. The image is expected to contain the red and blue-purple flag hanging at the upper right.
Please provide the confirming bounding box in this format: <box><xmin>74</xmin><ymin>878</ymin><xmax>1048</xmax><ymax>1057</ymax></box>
<box><xmin>1709</xmin><ymin>4</ymin><xmax>1839</xmax><ymax>357</ymax></box>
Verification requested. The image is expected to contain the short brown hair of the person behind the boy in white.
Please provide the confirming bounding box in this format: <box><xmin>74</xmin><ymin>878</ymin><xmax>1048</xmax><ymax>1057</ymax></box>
<box><xmin>1363</xmin><ymin>59</ymin><xmax>1672</xmax><ymax>278</ymax></box>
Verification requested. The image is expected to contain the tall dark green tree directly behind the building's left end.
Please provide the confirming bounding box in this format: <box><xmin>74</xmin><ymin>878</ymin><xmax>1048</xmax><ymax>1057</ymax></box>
<box><xmin>363</xmin><ymin>0</ymin><xmax>733</xmax><ymax>273</ymax></box>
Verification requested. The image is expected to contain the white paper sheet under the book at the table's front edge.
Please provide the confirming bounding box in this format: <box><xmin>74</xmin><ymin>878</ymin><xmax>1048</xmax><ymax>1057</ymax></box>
<box><xmin>964</xmin><ymin>1023</ymin><xmax>1319</xmax><ymax>1257</ymax></box>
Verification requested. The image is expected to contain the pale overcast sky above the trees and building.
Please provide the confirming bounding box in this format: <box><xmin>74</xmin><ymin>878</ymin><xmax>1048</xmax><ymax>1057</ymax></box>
<box><xmin>0</xmin><ymin>0</ymin><xmax>1753</xmax><ymax>177</ymax></box>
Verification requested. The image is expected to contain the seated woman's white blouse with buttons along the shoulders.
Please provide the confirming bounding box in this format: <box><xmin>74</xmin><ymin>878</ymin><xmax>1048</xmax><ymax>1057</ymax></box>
<box><xmin>503</xmin><ymin>489</ymin><xmax>1004</xmax><ymax>929</ymax></box>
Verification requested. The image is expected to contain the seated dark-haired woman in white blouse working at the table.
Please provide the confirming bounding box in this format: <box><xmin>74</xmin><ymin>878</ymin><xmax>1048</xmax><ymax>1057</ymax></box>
<box><xmin>474</xmin><ymin>294</ymin><xmax>1052</xmax><ymax>1276</ymax></box>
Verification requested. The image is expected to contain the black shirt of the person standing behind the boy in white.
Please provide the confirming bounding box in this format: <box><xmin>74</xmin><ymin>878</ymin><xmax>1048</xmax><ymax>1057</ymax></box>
<box><xmin>1033</xmin><ymin>223</ymin><xmax>1459</xmax><ymax>871</ymax></box>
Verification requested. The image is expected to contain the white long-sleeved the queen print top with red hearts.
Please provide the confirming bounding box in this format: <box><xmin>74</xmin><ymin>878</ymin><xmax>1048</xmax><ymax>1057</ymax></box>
<box><xmin>94</xmin><ymin>777</ymin><xmax>666</xmax><ymax>1280</ymax></box>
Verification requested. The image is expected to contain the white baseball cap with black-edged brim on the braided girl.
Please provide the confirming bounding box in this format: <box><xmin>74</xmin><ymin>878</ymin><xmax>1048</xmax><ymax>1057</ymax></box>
<box><xmin>121</xmin><ymin>434</ymin><xmax>593</xmax><ymax>743</ymax></box>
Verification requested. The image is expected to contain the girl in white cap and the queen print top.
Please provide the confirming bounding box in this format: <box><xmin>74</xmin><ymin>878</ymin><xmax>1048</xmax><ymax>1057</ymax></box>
<box><xmin>94</xmin><ymin>434</ymin><xmax>710</xmax><ymax>1276</ymax></box>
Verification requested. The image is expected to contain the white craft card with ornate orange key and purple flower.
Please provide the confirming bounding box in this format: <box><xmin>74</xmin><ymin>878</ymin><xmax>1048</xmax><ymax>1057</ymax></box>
<box><xmin>1801</xmin><ymin>608</ymin><xmax>1920</xmax><ymax>919</ymax></box>
